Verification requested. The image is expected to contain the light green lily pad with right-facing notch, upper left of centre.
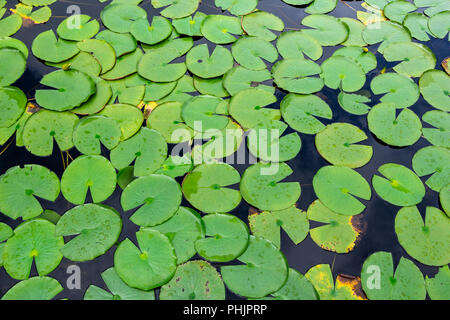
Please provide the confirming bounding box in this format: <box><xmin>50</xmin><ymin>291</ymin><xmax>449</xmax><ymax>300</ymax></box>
<box><xmin>137</xmin><ymin>38</ymin><xmax>193</xmax><ymax>82</ymax></box>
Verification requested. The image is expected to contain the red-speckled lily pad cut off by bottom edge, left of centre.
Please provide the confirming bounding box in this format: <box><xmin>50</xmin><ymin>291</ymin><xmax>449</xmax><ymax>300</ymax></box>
<box><xmin>159</xmin><ymin>260</ymin><xmax>225</xmax><ymax>300</ymax></box>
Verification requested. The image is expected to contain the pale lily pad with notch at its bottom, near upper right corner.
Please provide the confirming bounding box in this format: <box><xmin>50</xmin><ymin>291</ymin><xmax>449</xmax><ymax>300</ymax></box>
<box><xmin>363</xmin><ymin>21</ymin><xmax>411</xmax><ymax>54</ymax></box>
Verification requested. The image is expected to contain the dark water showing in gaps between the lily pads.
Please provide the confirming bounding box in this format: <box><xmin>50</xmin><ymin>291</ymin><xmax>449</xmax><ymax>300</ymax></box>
<box><xmin>0</xmin><ymin>0</ymin><xmax>449</xmax><ymax>299</ymax></box>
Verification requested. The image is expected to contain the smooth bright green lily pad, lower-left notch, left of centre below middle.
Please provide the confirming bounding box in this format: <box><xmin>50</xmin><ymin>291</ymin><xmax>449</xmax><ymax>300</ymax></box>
<box><xmin>120</xmin><ymin>174</ymin><xmax>182</xmax><ymax>227</ymax></box>
